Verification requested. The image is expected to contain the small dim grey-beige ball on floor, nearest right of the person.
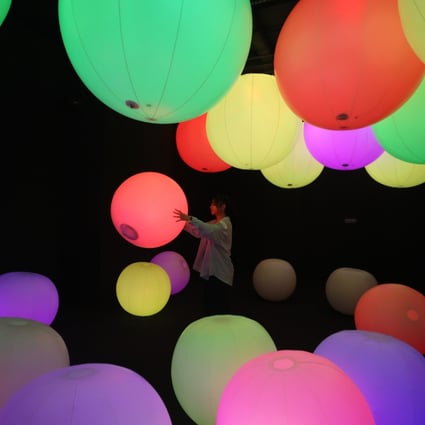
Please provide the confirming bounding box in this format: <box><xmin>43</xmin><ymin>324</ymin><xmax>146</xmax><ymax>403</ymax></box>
<box><xmin>252</xmin><ymin>258</ymin><xmax>297</xmax><ymax>301</ymax></box>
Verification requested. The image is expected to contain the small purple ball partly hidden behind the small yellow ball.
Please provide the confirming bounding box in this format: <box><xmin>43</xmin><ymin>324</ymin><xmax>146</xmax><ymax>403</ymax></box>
<box><xmin>151</xmin><ymin>251</ymin><xmax>190</xmax><ymax>295</ymax></box>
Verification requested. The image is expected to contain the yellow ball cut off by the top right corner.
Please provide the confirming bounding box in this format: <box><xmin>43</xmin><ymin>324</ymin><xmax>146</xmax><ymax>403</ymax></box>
<box><xmin>398</xmin><ymin>0</ymin><xmax>425</xmax><ymax>62</ymax></box>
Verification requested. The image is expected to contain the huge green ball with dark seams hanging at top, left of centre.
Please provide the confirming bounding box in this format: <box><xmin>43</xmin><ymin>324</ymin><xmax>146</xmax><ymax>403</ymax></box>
<box><xmin>59</xmin><ymin>0</ymin><xmax>252</xmax><ymax>123</ymax></box>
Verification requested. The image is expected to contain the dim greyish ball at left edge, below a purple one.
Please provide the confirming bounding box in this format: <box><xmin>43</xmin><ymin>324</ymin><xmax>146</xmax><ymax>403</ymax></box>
<box><xmin>0</xmin><ymin>317</ymin><xmax>69</xmax><ymax>406</ymax></box>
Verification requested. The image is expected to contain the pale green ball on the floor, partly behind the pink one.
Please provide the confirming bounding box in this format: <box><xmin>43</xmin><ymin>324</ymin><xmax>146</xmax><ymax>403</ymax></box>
<box><xmin>171</xmin><ymin>315</ymin><xmax>276</xmax><ymax>425</ymax></box>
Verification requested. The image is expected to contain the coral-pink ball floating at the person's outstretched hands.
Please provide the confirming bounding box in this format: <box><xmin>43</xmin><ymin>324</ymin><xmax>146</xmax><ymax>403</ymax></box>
<box><xmin>111</xmin><ymin>171</ymin><xmax>188</xmax><ymax>248</ymax></box>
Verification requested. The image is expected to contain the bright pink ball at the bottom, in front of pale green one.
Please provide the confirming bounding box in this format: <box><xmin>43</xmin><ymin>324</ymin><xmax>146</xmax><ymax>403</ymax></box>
<box><xmin>217</xmin><ymin>350</ymin><xmax>376</xmax><ymax>425</ymax></box>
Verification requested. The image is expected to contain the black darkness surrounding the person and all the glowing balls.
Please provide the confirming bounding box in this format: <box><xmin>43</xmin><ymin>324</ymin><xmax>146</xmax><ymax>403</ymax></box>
<box><xmin>0</xmin><ymin>0</ymin><xmax>425</xmax><ymax>425</ymax></box>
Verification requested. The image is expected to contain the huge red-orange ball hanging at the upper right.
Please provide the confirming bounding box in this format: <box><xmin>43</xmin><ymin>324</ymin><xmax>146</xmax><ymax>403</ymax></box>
<box><xmin>274</xmin><ymin>0</ymin><xmax>425</xmax><ymax>130</ymax></box>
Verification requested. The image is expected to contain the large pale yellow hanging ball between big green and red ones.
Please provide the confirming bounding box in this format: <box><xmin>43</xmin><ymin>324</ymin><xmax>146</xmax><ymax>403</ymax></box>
<box><xmin>206</xmin><ymin>74</ymin><xmax>299</xmax><ymax>170</ymax></box>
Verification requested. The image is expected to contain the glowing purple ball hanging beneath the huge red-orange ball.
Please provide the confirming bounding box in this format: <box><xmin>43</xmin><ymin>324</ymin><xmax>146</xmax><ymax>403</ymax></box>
<box><xmin>304</xmin><ymin>123</ymin><xmax>384</xmax><ymax>171</ymax></box>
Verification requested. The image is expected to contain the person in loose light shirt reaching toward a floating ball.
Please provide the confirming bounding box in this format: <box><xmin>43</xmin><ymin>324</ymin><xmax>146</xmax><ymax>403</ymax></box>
<box><xmin>174</xmin><ymin>194</ymin><xmax>234</xmax><ymax>315</ymax></box>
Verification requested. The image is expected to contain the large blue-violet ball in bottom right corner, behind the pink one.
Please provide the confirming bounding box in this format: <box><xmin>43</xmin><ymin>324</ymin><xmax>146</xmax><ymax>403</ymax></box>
<box><xmin>314</xmin><ymin>330</ymin><xmax>425</xmax><ymax>425</ymax></box>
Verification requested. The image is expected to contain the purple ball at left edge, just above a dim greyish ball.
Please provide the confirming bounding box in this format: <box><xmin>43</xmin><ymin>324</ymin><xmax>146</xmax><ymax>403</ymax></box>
<box><xmin>0</xmin><ymin>271</ymin><xmax>59</xmax><ymax>325</ymax></box>
